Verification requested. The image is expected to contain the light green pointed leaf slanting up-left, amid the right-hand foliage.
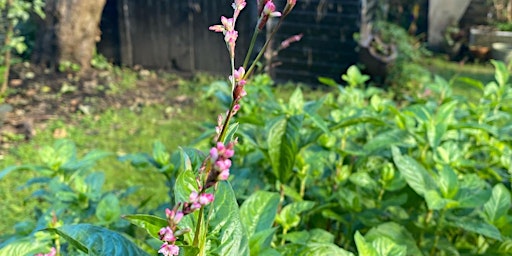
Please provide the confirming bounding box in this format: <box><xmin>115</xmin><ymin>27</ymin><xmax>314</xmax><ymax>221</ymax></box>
<box><xmin>392</xmin><ymin>147</ymin><xmax>435</xmax><ymax>196</ymax></box>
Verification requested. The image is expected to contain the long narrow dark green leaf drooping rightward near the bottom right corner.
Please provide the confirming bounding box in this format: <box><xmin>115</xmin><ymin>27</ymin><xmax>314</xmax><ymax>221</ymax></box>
<box><xmin>447</xmin><ymin>216</ymin><xmax>502</xmax><ymax>241</ymax></box>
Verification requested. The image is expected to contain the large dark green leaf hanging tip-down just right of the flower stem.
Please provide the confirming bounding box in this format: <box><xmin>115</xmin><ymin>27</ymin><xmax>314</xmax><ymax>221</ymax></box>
<box><xmin>267</xmin><ymin>115</ymin><xmax>304</xmax><ymax>184</ymax></box>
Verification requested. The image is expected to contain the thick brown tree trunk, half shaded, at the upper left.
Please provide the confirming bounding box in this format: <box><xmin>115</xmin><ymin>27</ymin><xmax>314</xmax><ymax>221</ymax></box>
<box><xmin>32</xmin><ymin>0</ymin><xmax>106</xmax><ymax>71</ymax></box>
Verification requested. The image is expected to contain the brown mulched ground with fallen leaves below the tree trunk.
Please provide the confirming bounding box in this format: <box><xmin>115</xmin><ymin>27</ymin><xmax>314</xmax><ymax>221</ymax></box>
<box><xmin>0</xmin><ymin>64</ymin><xmax>193</xmax><ymax>156</ymax></box>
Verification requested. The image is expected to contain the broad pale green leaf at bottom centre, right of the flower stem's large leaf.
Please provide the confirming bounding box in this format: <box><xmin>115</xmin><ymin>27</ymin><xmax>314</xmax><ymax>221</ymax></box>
<box><xmin>240</xmin><ymin>190</ymin><xmax>279</xmax><ymax>237</ymax></box>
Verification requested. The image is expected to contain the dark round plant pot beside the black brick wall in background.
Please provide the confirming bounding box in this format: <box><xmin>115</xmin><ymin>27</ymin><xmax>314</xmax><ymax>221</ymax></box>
<box><xmin>359</xmin><ymin>36</ymin><xmax>398</xmax><ymax>78</ymax></box>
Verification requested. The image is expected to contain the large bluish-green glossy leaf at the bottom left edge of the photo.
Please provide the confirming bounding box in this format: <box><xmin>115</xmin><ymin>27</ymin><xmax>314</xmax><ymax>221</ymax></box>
<box><xmin>45</xmin><ymin>224</ymin><xmax>149</xmax><ymax>256</ymax></box>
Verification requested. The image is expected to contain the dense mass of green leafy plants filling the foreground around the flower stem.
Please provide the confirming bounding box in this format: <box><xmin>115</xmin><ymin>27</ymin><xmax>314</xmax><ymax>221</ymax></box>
<box><xmin>0</xmin><ymin>62</ymin><xmax>512</xmax><ymax>255</ymax></box>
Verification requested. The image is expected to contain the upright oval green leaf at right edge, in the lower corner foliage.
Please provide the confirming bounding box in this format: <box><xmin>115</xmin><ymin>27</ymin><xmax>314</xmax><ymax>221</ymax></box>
<box><xmin>484</xmin><ymin>183</ymin><xmax>510</xmax><ymax>224</ymax></box>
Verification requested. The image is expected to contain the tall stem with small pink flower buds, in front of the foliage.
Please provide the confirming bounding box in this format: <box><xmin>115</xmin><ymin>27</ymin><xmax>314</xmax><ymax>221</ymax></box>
<box><xmin>154</xmin><ymin>0</ymin><xmax>300</xmax><ymax>255</ymax></box>
